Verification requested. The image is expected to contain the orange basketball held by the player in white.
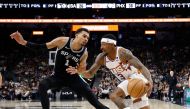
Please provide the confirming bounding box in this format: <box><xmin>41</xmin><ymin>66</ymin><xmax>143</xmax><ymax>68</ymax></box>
<box><xmin>127</xmin><ymin>78</ymin><xmax>146</xmax><ymax>98</ymax></box>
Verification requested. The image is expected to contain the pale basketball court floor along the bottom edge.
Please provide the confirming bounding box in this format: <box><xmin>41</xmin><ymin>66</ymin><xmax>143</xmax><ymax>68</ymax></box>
<box><xmin>0</xmin><ymin>99</ymin><xmax>190</xmax><ymax>109</ymax></box>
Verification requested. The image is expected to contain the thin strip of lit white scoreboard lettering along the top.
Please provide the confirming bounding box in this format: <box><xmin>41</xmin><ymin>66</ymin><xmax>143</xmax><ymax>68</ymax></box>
<box><xmin>0</xmin><ymin>2</ymin><xmax>190</xmax><ymax>9</ymax></box>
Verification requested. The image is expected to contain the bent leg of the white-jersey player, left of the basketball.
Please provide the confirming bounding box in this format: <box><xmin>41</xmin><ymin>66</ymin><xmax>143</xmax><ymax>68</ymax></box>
<box><xmin>110</xmin><ymin>80</ymin><xmax>128</xmax><ymax>109</ymax></box>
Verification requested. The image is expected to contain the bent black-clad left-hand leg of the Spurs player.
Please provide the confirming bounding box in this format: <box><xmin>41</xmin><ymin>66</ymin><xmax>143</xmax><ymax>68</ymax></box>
<box><xmin>38</xmin><ymin>76</ymin><xmax>62</xmax><ymax>109</ymax></box>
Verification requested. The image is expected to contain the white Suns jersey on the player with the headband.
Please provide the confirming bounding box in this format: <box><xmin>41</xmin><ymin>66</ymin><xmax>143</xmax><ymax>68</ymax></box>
<box><xmin>105</xmin><ymin>47</ymin><xmax>138</xmax><ymax>81</ymax></box>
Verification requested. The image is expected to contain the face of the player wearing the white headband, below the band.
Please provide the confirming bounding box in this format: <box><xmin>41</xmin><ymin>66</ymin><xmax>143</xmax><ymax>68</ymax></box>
<box><xmin>100</xmin><ymin>42</ymin><xmax>113</xmax><ymax>53</ymax></box>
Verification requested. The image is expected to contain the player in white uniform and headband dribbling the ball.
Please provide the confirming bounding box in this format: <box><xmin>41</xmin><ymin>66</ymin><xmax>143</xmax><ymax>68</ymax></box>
<box><xmin>67</xmin><ymin>34</ymin><xmax>152</xmax><ymax>109</ymax></box>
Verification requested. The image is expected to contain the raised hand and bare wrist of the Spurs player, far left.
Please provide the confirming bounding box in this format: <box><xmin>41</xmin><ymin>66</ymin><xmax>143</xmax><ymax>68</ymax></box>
<box><xmin>10</xmin><ymin>31</ymin><xmax>27</xmax><ymax>45</ymax></box>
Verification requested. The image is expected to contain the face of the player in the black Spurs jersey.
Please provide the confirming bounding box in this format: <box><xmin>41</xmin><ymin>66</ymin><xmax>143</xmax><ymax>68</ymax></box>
<box><xmin>76</xmin><ymin>31</ymin><xmax>90</xmax><ymax>46</ymax></box>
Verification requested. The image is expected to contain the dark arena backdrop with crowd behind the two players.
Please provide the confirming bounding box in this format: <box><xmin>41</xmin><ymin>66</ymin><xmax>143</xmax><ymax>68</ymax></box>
<box><xmin>0</xmin><ymin>0</ymin><xmax>190</xmax><ymax>108</ymax></box>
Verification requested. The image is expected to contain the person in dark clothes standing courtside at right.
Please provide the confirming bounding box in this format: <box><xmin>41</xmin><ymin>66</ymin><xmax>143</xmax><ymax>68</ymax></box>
<box><xmin>168</xmin><ymin>70</ymin><xmax>177</xmax><ymax>101</ymax></box>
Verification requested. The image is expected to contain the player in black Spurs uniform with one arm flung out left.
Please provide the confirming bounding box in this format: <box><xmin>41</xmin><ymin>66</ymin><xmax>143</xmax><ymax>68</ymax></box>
<box><xmin>10</xmin><ymin>28</ymin><xmax>108</xmax><ymax>109</ymax></box>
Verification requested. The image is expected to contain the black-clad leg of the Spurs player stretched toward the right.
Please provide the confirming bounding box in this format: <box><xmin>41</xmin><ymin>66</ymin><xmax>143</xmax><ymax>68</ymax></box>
<box><xmin>70</xmin><ymin>78</ymin><xmax>109</xmax><ymax>109</ymax></box>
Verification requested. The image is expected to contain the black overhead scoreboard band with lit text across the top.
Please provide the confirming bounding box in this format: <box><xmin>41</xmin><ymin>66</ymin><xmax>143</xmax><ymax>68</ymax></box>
<box><xmin>0</xmin><ymin>1</ymin><xmax>190</xmax><ymax>19</ymax></box>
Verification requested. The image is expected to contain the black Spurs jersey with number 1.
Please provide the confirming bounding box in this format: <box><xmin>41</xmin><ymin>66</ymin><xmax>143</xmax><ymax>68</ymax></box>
<box><xmin>54</xmin><ymin>38</ymin><xmax>86</xmax><ymax>77</ymax></box>
